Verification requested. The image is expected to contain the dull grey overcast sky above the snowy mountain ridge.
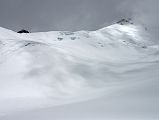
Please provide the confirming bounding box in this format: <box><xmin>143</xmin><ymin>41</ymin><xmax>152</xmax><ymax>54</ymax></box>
<box><xmin>0</xmin><ymin>0</ymin><xmax>159</xmax><ymax>31</ymax></box>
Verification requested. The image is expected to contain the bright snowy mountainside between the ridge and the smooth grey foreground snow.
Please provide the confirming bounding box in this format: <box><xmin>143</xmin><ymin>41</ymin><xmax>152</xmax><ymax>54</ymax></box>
<box><xmin>0</xmin><ymin>24</ymin><xmax>159</xmax><ymax>119</ymax></box>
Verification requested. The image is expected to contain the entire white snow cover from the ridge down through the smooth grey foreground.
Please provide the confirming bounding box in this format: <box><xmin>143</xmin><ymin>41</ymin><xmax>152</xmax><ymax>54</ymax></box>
<box><xmin>0</xmin><ymin>24</ymin><xmax>159</xmax><ymax>120</ymax></box>
